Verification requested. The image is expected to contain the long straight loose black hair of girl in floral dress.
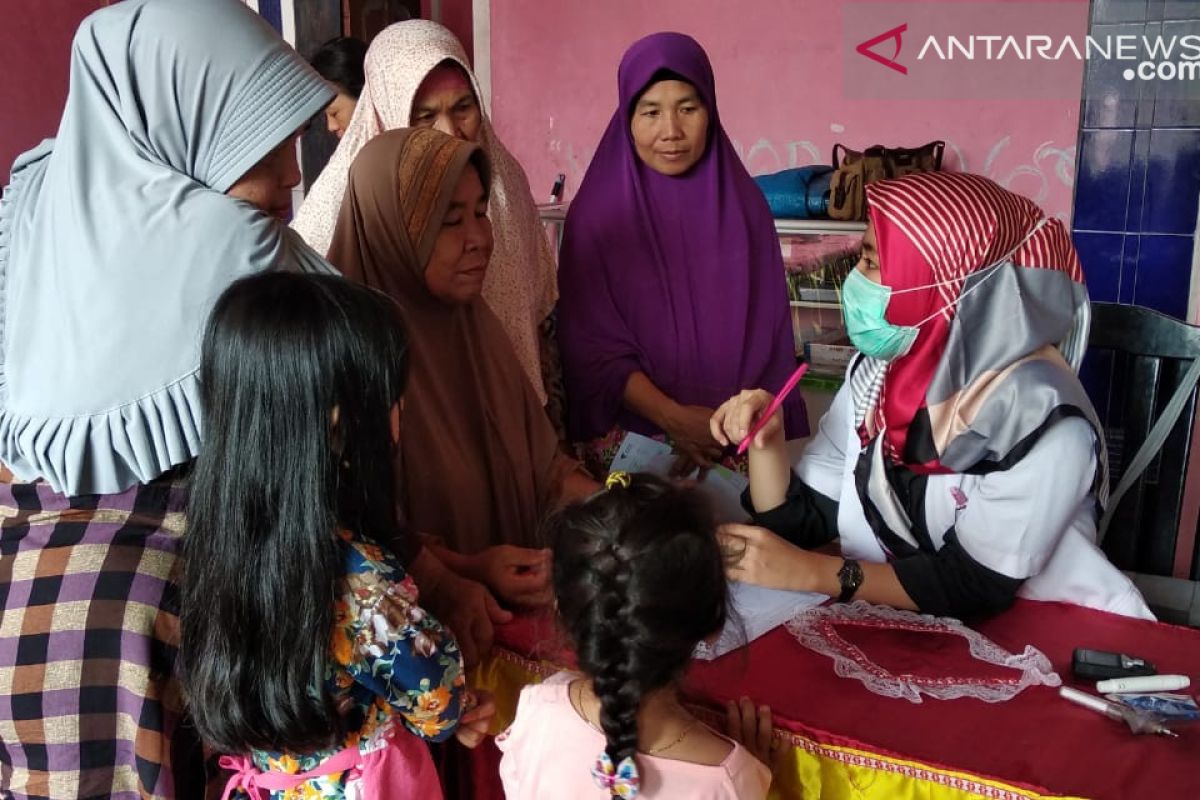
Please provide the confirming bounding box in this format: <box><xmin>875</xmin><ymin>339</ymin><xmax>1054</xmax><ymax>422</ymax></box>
<box><xmin>179</xmin><ymin>272</ymin><xmax>408</xmax><ymax>752</ymax></box>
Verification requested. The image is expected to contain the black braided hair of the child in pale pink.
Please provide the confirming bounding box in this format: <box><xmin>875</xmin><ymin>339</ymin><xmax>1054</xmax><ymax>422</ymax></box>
<box><xmin>548</xmin><ymin>474</ymin><xmax>728</xmax><ymax>786</ymax></box>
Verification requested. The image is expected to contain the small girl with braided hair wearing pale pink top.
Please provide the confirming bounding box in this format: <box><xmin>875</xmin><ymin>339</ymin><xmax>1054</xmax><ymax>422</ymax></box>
<box><xmin>497</xmin><ymin>473</ymin><xmax>770</xmax><ymax>800</ymax></box>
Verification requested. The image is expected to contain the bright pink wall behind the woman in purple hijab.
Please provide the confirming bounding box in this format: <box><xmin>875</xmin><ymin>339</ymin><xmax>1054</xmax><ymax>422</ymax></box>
<box><xmin>491</xmin><ymin>0</ymin><xmax>1088</xmax><ymax>219</ymax></box>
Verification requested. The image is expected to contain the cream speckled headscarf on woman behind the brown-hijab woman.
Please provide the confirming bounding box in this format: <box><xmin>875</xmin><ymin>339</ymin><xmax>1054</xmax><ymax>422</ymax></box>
<box><xmin>292</xmin><ymin>19</ymin><xmax>558</xmax><ymax>404</ymax></box>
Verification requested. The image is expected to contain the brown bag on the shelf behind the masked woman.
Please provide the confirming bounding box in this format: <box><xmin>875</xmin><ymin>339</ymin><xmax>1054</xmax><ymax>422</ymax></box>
<box><xmin>829</xmin><ymin>140</ymin><xmax>946</xmax><ymax>222</ymax></box>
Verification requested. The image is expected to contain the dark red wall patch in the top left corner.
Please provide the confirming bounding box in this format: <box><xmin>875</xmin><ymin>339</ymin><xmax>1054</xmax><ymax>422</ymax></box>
<box><xmin>0</xmin><ymin>0</ymin><xmax>108</xmax><ymax>176</ymax></box>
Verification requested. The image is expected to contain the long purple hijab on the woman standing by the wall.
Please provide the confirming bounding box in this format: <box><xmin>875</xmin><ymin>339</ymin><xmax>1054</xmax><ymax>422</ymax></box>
<box><xmin>558</xmin><ymin>34</ymin><xmax>808</xmax><ymax>441</ymax></box>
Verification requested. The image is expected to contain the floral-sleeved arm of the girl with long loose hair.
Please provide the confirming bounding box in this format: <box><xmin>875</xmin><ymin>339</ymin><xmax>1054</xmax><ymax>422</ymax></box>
<box><xmin>334</xmin><ymin>540</ymin><xmax>466</xmax><ymax>741</ymax></box>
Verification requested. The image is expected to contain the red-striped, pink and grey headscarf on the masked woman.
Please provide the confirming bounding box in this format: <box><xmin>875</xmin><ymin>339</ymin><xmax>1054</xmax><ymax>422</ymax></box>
<box><xmin>860</xmin><ymin>173</ymin><xmax>1091</xmax><ymax>473</ymax></box>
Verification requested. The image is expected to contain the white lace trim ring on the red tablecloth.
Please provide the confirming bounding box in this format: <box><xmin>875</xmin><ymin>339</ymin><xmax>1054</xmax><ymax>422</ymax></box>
<box><xmin>787</xmin><ymin>601</ymin><xmax>1062</xmax><ymax>703</ymax></box>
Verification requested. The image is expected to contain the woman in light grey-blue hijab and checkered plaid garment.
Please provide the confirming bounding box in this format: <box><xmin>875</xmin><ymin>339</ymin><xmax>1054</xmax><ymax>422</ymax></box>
<box><xmin>0</xmin><ymin>0</ymin><xmax>334</xmax><ymax>798</ymax></box>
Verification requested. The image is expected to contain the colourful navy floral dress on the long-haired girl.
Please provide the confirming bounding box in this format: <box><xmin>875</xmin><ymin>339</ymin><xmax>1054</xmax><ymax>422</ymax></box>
<box><xmin>241</xmin><ymin>531</ymin><xmax>466</xmax><ymax>800</ymax></box>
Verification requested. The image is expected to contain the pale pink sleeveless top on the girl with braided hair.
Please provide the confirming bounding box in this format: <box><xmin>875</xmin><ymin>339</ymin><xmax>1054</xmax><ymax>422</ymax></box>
<box><xmin>496</xmin><ymin>672</ymin><xmax>770</xmax><ymax>800</ymax></box>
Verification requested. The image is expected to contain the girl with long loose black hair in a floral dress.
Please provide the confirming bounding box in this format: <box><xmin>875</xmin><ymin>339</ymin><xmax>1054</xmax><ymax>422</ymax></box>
<box><xmin>180</xmin><ymin>272</ymin><xmax>491</xmax><ymax>798</ymax></box>
